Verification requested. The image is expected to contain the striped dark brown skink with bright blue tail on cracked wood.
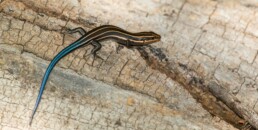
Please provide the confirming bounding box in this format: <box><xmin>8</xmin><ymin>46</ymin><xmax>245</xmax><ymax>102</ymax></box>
<box><xmin>29</xmin><ymin>25</ymin><xmax>161</xmax><ymax>125</ymax></box>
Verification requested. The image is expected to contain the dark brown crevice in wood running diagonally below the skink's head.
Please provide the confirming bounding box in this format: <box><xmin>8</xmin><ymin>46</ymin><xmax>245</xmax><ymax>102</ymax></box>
<box><xmin>138</xmin><ymin>47</ymin><xmax>255</xmax><ymax>129</ymax></box>
